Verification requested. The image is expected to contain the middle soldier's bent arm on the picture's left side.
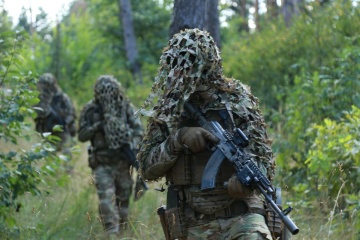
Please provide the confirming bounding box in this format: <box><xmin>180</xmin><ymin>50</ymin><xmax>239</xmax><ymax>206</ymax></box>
<box><xmin>78</xmin><ymin>102</ymin><xmax>102</xmax><ymax>142</ymax></box>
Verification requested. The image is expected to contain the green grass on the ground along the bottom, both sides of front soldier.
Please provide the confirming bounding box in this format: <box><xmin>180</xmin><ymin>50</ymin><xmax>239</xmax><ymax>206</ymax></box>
<box><xmin>0</xmin><ymin>144</ymin><xmax>360</xmax><ymax>240</ymax></box>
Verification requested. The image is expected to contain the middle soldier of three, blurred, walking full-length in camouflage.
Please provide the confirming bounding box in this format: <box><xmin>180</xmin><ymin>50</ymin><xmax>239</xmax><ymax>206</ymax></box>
<box><xmin>78</xmin><ymin>75</ymin><xmax>143</xmax><ymax>234</ymax></box>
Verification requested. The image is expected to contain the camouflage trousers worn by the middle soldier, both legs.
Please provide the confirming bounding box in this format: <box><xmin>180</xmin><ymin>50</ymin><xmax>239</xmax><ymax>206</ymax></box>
<box><xmin>93</xmin><ymin>160</ymin><xmax>133</xmax><ymax>233</ymax></box>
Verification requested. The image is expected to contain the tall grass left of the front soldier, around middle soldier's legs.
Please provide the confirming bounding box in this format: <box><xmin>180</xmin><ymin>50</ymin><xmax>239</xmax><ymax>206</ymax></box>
<box><xmin>9</xmin><ymin>145</ymin><xmax>165</xmax><ymax>240</ymax></box>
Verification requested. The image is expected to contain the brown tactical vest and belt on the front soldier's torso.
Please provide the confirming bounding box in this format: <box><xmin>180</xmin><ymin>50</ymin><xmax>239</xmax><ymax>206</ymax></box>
<box><xmin>166</xmin><ymin>111</ymin><xmax>264</xmax><ymax>238</ymax></box>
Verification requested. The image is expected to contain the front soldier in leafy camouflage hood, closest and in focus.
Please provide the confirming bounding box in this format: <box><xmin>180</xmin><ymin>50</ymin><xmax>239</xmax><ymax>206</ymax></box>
<box><xmin>137</xmin><ymin>29</ymin><xmax>275</xmax><ymax>239</ymax></box>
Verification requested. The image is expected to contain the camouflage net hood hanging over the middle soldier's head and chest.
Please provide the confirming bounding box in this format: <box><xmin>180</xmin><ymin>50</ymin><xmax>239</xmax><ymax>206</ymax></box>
<box><xmin>94</xmin><ymin>75</ymin><xmax>131</xmax><ymax>149</ymax></box>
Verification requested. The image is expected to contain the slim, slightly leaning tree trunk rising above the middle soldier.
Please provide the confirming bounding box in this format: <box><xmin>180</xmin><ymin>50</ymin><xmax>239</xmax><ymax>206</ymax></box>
<box><xmin>118</xmin><ymin>0</ymin><xmax>143</xmax><ymax>84</ymax></box>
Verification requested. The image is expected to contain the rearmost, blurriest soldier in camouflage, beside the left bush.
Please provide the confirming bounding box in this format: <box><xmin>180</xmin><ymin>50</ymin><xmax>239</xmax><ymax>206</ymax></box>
<box><xmin>35</xmin><ymin>73</ymin><xmax>76</xmax><ymax>155</ymax></box>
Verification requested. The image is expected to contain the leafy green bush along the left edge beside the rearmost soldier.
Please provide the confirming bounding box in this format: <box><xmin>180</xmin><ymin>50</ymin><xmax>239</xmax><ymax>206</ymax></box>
<box><xmin>0</xmin><ymin>31</ymin><xmax>61</xmax><ymax>233</ymax></box>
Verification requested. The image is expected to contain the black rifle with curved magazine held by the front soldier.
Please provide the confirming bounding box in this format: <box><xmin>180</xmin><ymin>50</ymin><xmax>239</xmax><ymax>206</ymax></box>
<box><xmin>184</xmin><ymin>102</ymin><xmax>299</xmax><ymax>235</ymax></box>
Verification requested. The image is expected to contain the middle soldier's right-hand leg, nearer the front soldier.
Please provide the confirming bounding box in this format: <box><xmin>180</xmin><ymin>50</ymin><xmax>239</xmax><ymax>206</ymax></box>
<box><xmin>115</xmin><ymin>160</ymin><xmax>133</xmax><ymax>223</ymax></box>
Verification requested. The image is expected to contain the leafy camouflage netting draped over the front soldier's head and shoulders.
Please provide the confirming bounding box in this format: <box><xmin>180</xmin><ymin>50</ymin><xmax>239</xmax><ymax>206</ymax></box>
<box><xmin>138</xmin><ymin>29</ymin><xmax>274</xmax><ymax>179</ymax></box>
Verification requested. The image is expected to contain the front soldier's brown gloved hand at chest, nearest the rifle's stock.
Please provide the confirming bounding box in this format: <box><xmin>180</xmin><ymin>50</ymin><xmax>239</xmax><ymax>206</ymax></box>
<box><xmin>177</xmin><ymin>127</ymin><xmax>219</xmax><ymax>153</ymax></box>
